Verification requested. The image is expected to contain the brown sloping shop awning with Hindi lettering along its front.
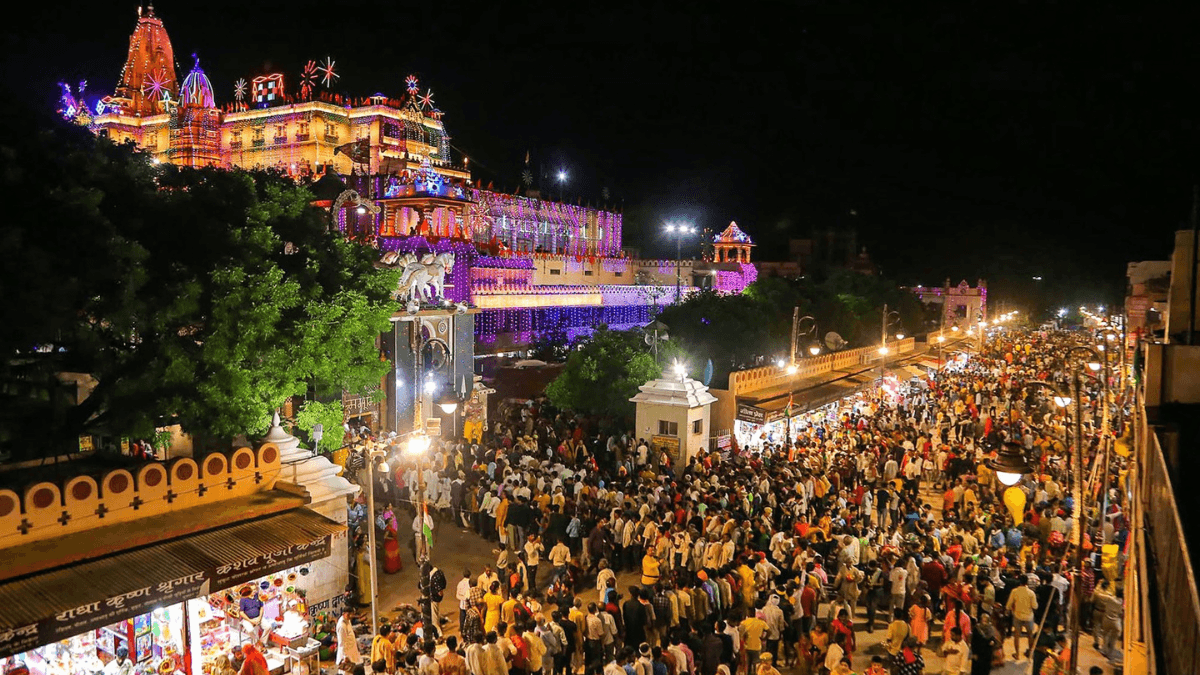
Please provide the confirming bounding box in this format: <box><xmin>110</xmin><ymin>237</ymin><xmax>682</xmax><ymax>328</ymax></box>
<box><xmin>0</xmin><ymin>508</ymin><xmax>346</xmax><ymax>658</ymax></box>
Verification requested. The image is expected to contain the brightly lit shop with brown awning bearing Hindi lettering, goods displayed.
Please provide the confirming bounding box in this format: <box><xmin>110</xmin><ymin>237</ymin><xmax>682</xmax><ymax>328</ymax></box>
<box><xmin>0</xmin><ymin>508</ymin><xmax>344</xmax><ymax>675</ymax></box>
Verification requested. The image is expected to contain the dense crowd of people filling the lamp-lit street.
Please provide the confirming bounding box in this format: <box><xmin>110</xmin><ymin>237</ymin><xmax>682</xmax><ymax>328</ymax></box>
<box><xmin>338</xmin><ymin>331</ymin><xmax>1127</xmax><ymax>675</ymax></box>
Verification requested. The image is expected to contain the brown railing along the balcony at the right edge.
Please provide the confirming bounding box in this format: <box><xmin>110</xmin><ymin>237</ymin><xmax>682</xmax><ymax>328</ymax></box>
<box><xmin>1140</xmin><ymin>417</ymin><xmax>1200</xmax><ymax>673</ymax></box>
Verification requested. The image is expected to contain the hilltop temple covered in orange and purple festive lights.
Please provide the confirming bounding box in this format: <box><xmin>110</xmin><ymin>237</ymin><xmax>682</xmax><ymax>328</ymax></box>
<box><xmin>62</xmin><ymin>6</ymin><xmax>756</xmax><ymax>354</ymax></box>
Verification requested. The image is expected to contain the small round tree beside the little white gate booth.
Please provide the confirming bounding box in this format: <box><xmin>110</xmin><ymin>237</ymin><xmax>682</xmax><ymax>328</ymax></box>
<box><xmin>546</xmin><ymin>325</ymin><xmax>662</xmax><ymax>417</ymax></box>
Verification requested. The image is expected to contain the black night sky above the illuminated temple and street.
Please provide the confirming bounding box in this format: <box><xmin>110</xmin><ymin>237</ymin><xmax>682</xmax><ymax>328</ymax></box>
<box><xmin>4</xmin><ymin>0</ymin><xmax>1200</xmax><ymax>301</ymax></box>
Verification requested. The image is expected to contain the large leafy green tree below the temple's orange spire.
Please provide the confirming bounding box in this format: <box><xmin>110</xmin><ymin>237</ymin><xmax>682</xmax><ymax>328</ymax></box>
<box><xmin>0</xmin><ymin>111</ymin><xmax>396</xmax><ymax>456</ymax></box>
